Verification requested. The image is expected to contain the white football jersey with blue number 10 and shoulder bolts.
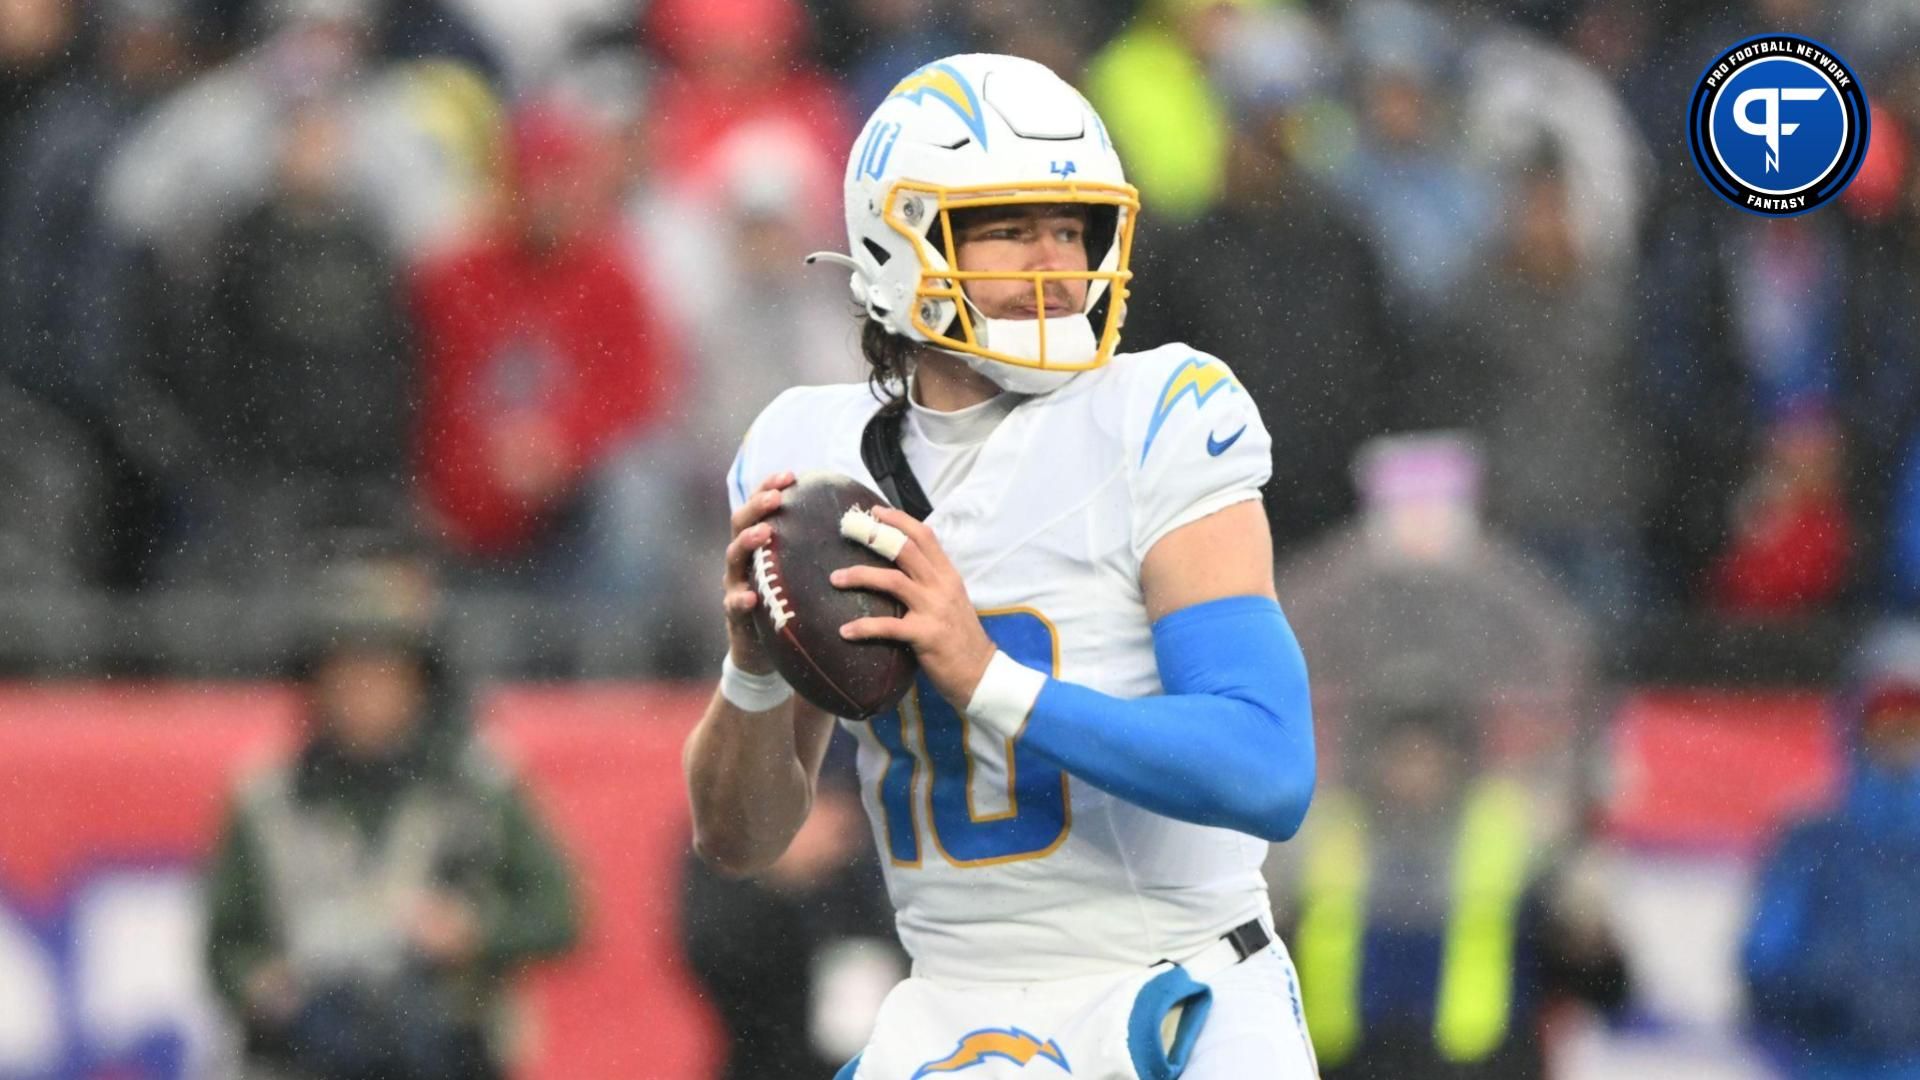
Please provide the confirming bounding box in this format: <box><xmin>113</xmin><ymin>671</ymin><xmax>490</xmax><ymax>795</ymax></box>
<box><xmin>728</xmin><ymin>346</ymin><xmax>1271</xmax><ymax>982</ymax></box>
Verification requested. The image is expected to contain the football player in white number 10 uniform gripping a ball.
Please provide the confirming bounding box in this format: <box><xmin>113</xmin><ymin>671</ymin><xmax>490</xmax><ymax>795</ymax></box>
<box><xmin>685</xmin><ymin>56</ymin><xmax>1315</xmax><ymax>1080</ymax></box>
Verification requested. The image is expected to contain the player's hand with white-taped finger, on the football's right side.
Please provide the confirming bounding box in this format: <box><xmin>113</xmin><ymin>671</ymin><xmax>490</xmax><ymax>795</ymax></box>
<box><xmin>833</xmin><ymin>505</ymin><xmax>995</xmax><ymax>709</ymax></box>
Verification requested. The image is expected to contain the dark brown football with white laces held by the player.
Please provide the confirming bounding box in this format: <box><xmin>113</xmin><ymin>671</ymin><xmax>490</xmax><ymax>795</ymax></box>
<box><xmin>753</xmin><ymin>473</ymin><xmax>920</xmax><ymax>721</ymax></box>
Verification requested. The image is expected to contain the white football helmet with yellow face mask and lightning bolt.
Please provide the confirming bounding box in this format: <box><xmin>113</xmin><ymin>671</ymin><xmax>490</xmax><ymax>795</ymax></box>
<box><xmin>808</xmin><ymin>54</ymin><xmax>1140</xmax><ymax>394</ymax></box>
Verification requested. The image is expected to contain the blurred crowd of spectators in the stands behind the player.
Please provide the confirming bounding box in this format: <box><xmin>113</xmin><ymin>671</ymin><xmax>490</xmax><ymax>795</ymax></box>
<box><xmin>0</xmin><ymin>0</ymin><xmax>1920</xmax><ymax>675</ymax></box>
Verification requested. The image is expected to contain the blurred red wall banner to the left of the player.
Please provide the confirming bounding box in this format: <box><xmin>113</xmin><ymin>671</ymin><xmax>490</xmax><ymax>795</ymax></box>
<box><xmin>0</xmin><ymin>684</ymin><xmax>718</xmax><ymax>1080</ymax></box>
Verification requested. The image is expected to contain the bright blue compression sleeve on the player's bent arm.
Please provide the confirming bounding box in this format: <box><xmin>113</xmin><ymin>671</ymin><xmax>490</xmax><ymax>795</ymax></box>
<box><xmin>1023</xmin><ymin>596</ymin><xmax>1313</xmax><ymax>840</ymax></box>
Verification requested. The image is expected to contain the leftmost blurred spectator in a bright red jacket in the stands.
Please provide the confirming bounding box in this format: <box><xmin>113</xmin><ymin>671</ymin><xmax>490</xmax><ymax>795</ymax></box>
<box><xmin>415</xmin><ymin>106</ymin><xmax>674</xmax><ymax>582</ymax></box>
